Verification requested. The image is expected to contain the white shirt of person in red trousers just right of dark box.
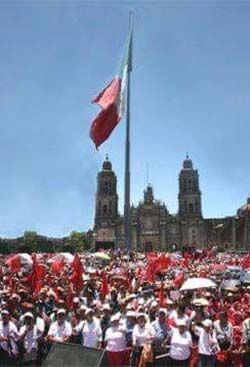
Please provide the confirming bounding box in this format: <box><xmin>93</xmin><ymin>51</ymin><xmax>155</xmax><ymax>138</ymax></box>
<box><xmin>105</xmin><ymin>326</ymin><xmax>127</xmax><ymax>352</ymax></box>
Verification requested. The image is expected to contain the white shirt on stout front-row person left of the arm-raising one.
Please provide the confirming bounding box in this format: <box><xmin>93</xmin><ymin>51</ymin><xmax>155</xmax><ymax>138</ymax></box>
<box><xmin>170</xmin><ymin>328</ymin><xmax>192</xmax><ymax>361</ymax></box>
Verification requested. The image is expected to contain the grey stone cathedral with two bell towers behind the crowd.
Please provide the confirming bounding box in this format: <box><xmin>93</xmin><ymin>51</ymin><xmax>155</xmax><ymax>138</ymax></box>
<box><xmin>93</xmin><ymin>155</ymin><xmax>250</xmax><ymax>251</ymax></box>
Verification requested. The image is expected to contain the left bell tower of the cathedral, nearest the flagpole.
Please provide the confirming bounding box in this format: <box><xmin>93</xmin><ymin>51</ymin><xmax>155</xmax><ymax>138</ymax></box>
<box><xmin>95</xmin><ymin>156</ymin><xmax>118</xmax><ymax>227</ymax></box>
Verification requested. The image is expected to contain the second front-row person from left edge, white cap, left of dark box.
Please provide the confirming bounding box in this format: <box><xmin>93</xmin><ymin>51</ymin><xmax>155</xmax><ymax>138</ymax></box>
<box><xmin>19</xmin><ymin>312</ymin><xmax>43</xmax><ymax>362</ymax></box>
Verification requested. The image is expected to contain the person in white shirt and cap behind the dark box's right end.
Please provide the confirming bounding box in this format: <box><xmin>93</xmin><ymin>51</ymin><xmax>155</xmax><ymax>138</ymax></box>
<box><xmin>75</xmin><ymin>308</ymin><xmax>102</xmax><ymax>348</ymax></box>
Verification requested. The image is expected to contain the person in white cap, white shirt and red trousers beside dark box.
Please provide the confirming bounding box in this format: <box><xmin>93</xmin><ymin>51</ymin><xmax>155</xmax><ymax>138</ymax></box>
<box><xmin>105</xmin><ymin>312</ymin><xmax>128</xmax><ymax>367</ymax></box>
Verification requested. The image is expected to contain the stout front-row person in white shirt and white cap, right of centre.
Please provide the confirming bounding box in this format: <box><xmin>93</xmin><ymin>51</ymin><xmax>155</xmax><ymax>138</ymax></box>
<box><xmin>169</xmin><ymin>320</ymin><xmax>193</xmax><ymax>367</ymax></box>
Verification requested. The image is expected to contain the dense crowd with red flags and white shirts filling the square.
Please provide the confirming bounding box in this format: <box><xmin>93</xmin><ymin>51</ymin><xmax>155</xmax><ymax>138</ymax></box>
<box><xmin>0</xmin><ymin>248</ymin><xmax>250</xmax><ymax>367</ymax></box>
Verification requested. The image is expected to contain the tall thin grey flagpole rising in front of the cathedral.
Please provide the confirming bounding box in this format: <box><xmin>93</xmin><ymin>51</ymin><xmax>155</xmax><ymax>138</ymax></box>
<box><xmin>124</xmin><ymin>11</ymin><xmax>133</xmax><ymax>251</ymax></box>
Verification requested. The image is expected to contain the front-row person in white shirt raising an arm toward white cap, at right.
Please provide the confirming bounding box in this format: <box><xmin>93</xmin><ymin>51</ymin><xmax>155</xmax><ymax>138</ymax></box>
<box><xmin>194</xmin><ymin>319</ymin><xmax>220</xmax><ymax>367</ymax></box>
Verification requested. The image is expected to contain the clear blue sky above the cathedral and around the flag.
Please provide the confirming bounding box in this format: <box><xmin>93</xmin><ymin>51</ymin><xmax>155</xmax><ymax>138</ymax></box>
<box><xmin>0</xmin><ymin>1</ymin><xmax>250</xmax><ymax>237</ymax></box>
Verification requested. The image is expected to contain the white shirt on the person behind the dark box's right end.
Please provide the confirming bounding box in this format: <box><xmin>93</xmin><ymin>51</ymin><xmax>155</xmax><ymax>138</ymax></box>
<box><xmin>82</xmin><ymin>319</ymin><xmax>102</xmax><ymax>348</ymax></box>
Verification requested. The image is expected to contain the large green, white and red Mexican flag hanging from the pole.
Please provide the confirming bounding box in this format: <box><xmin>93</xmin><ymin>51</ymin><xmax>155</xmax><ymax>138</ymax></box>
<box><xmin>90</xmin><ymin>29</ymin><xmax>132</xmax><ymax>148</ymax></box>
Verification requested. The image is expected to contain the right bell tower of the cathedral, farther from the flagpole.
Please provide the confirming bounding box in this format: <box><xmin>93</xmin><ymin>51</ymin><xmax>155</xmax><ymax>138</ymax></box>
<box><xmin>178</xmin><ymin>154</ymin><xmax>202</xmax><ymax>219</ymax></box>
